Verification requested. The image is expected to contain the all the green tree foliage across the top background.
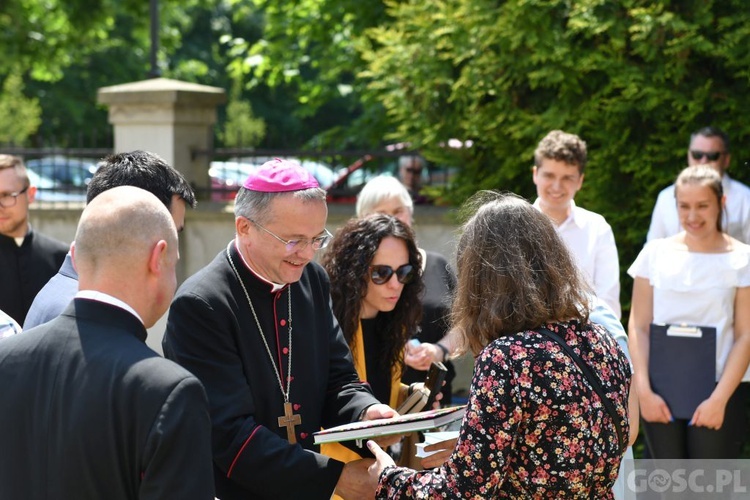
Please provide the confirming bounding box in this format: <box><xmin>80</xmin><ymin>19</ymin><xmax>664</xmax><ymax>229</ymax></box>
<box><xmin>5</xmin><ymin>0</ymin><xmax>750</xmax><ymax>308</ymax></box>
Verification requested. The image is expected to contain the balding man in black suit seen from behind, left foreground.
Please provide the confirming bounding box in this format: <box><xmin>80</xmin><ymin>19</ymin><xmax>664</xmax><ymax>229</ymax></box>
<box><xmin>0</xmin><ymin>186</ymin><xmax>214</xmax><ymax>500</ymax></box>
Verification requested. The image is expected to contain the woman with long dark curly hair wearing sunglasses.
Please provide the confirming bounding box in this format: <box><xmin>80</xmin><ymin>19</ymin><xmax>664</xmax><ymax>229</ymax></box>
<box><xmin>321</xmin><ymin>214</ymin><xmax>423</xmax><ymax>468</ymax></box>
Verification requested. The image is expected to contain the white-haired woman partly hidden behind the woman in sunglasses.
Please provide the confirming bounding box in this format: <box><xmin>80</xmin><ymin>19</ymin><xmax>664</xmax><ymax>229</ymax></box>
<box><xmin>357</xmin><ymin>176</ymin><xmax>456</xmax><ymax>405</ymax></box>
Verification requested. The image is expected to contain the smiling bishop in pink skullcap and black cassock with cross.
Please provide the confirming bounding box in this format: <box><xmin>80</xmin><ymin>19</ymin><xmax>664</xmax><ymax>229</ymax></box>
<box><xmin>164</xmin><ymin>159</ymin><xmax>398</xmax><ymax>500</ymax></box>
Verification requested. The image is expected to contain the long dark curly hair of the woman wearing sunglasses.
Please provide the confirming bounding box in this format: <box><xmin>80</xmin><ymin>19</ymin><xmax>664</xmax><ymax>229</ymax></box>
<box><xmin>322</xmin><ymin>214</ymin><xmax>424</xmax><ymax>368</ymax></box>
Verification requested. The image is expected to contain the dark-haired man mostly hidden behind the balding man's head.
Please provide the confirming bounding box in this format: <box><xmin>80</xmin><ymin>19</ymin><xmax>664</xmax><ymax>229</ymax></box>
<box><xmin>23</xmin><ymin>151</ymin><xmax>196</xmax><ymax>330</ymax></box>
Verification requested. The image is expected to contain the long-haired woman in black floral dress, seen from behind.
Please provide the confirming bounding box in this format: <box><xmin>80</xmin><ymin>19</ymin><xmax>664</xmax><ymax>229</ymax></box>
<box><xmin>367</xmin><ymin>191</ymin><xmax>635</xmax><ymax>498</ymax></box>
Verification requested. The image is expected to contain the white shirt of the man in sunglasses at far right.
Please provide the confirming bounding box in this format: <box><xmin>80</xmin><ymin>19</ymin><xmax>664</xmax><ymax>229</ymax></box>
<box><xmin>646</xmin><ymin>174</ymin><xmax>750</xmax><ymax>244</ymax></box>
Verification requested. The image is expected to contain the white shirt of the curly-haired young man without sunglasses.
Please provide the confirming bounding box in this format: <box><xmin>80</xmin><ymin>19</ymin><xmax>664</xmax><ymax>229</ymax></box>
<box><xmin>534</xmin><ymin>198</ymin><xmax>622</xmax><ymax>318</ymax></box>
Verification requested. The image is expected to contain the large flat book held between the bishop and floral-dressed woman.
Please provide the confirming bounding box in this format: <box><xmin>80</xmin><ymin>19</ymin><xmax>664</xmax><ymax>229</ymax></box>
<box><xmin>314</xmin><ymin>405</ymin><xmax>466</xmax><ymax>444</ymax></box>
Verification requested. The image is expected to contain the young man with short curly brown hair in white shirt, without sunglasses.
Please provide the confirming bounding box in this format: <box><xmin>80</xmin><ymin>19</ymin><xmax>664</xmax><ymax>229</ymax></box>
<box><xmin>533</xmin><ymin>130</ymin><xmax>621</xmax><ymax>318</ymax></box>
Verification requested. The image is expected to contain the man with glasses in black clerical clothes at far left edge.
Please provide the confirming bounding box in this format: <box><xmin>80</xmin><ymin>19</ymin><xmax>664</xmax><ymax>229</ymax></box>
<box><xmin>0</xmin><ymin>154</ymin><xmax>68</xmax><ymax>324</ymax></box>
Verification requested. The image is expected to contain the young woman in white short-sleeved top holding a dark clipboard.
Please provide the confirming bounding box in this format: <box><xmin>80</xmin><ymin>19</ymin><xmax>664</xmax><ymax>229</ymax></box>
<box><xmin>628</xmin><ymin>166</ymin><xmax>750</xmax><ymax>459</ymax></box>
